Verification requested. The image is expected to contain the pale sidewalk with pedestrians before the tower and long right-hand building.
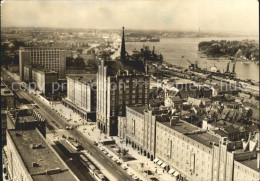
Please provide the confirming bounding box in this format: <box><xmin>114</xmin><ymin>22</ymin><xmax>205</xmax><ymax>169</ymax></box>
<box><xmin>78</xmin><ymin>125</ymin><xmax>175</xmax><ymax>181</ymax></box>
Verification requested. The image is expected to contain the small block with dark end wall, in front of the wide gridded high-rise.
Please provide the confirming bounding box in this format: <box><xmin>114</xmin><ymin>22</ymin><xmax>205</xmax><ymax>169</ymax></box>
<box><xmin>32</xmin><ymin>68</ymin><xmax>58</xmax><ymax>95</ymax></box>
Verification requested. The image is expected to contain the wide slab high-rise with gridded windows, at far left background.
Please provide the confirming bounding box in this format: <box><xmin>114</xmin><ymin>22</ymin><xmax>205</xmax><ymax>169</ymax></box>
<box><xmin>19</xmin><ymin>47</ymin><xmax>66</xmax><ymax>80</ymax></box>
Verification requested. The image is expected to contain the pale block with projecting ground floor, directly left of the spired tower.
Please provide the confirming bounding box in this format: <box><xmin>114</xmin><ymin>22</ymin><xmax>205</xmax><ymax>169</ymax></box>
<box><xmin>62</xmin><ymin>74</ymin><xmax>96</xmax><ymax>121</ymax></box>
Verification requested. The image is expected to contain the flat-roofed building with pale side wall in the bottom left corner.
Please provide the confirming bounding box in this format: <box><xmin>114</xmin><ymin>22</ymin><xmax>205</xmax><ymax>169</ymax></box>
<box><xmin>6</xmin><ymin>129</ymin><xmax>79</xmax><ymax>181</ymax></box>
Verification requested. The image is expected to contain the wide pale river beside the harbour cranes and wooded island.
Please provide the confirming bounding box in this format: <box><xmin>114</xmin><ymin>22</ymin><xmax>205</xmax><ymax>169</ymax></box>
<box><xmin>126</xmin><ymin>37</ymin><xmax>259</xmax><ymax>82</ymax></box>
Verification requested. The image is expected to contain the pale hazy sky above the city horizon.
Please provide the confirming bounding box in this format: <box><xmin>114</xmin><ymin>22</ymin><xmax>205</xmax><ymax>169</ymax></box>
<box><xmin>1</xmin><ymin>0</ymin><xmax>259</xmax><ymax>32</ymax></box>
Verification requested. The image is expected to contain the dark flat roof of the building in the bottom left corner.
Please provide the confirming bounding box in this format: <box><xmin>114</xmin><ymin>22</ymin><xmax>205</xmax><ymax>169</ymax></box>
<box><xmin>8</xmin><ymin>129</ymin><xmax>75</xmax><ymax>180</ymax></box>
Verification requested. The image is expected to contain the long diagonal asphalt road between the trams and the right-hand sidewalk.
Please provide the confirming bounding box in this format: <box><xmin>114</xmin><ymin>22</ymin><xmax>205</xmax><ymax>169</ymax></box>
<box><xmin>2</xmin><ymin>70</ymin><xmax>134</xmax><ymax>181</ymax></box>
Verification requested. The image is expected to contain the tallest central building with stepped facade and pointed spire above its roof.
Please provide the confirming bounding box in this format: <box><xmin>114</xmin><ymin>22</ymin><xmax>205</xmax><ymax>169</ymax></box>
<box><xmin>97</xmin><ymin>28</ymin><xmax>150</xmax><ymax>136</ymax></box>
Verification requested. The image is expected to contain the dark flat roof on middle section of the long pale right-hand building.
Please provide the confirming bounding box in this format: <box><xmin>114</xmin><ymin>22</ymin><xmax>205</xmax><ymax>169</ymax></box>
<box><xmin>160</xmin><ymin>120</ymin><xmax>220</xmax><ymax>148</ymax></box>
